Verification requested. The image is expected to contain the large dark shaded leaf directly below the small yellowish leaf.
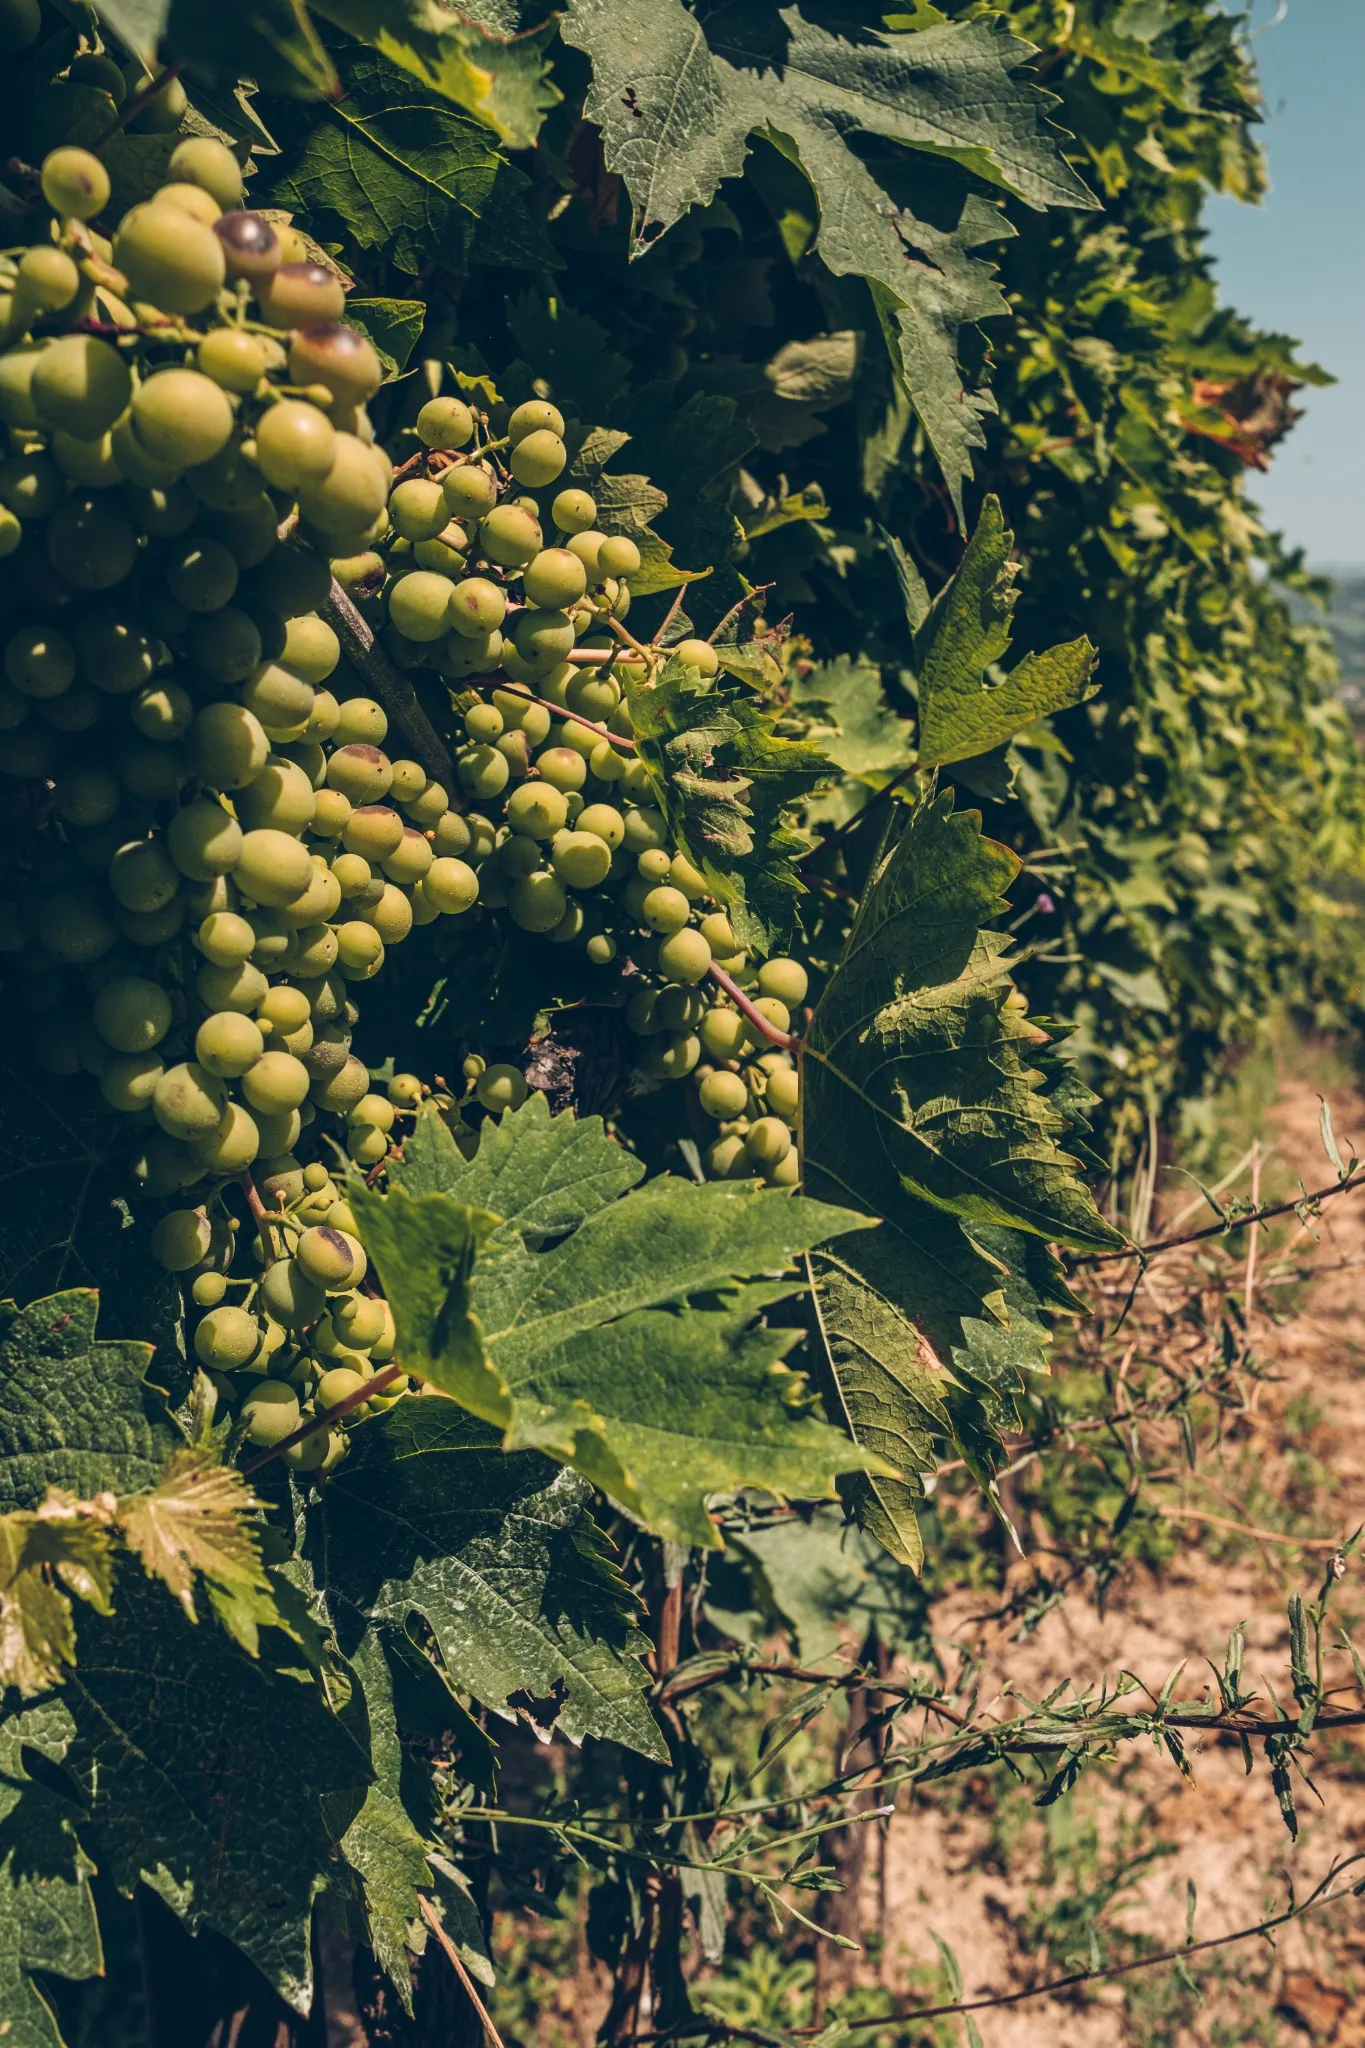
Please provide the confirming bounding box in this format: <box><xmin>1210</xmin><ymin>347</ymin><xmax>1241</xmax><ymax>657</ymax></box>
<box><xmin>63</xmin><ymin>1569</ymin><xmax>370</xmax><ymax>2011</ymax></box>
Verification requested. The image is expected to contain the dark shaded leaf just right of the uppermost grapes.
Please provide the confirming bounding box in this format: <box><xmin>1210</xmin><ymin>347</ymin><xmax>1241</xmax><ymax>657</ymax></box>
<box><xmin>268</xmin><ymin>49</ymin><xmax>540</xmax><ymax>276</ymax></box>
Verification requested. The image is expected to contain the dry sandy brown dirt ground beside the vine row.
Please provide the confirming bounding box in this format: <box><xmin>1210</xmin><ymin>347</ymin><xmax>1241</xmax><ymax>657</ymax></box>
<box><xmin>884</xmin><ymin>1071</ymin><xmax>1365</xmax><ymax>2048</ymax></box>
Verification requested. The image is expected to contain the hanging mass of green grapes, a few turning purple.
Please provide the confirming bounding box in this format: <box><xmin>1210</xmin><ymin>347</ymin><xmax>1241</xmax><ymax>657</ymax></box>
<box><xmin>0</xmin><ymin>137</ymin><xmax>806</xmax><ymax>1470</ymax></box>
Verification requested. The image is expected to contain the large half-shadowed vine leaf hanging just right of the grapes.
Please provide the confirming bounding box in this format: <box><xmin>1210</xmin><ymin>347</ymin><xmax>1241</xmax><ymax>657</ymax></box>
<box><xmin>802</xmin><ymin>793</ymin><xmax>1121</xmax><ymax>1567</ymax></box>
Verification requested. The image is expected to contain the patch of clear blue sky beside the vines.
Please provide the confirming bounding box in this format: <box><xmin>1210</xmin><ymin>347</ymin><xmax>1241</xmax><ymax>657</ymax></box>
<box><xmin>1207</xmin><ymin>0</ymin><xmax>1365</xmax><ymax>567</ymax></box>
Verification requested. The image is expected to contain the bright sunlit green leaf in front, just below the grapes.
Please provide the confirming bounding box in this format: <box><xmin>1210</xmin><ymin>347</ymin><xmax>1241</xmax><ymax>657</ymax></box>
<box><xmin>352</xmin><ymin>1104</ymin><xmax>876</xmax><ymax>1546</ymax></box>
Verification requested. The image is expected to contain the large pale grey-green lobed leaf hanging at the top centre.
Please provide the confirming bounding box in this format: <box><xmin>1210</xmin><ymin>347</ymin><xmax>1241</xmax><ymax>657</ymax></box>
<box><xmin>563</xmin><ymin>0</ymin><xmax>1095</xmax><ymax>504</ymax></box>
